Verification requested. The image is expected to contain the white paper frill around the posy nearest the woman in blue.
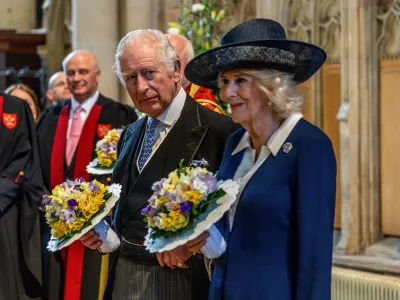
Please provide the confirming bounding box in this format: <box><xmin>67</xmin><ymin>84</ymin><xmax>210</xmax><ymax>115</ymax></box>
<box><xmin>144</xmin><ymin>180</ymin><xmax>239</xmax><ymax>253</ymax></box>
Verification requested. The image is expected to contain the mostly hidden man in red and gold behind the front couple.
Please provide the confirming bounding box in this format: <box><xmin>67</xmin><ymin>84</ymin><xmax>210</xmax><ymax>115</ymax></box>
<box><xmin>167</xmin><ymin>34</ymin><xmax>224</xmax><ymax>113</ymax></box>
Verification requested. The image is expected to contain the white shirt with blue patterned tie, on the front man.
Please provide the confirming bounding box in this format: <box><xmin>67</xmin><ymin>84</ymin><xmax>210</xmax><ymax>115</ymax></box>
<box><xmin>136</xmin><ymin>87</ymin><xmax>186</xmax><ymax>170</ymax></box>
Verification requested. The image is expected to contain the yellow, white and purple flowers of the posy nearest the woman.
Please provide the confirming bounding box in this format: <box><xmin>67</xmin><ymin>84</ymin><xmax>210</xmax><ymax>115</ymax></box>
<box><xmin>142</xmin><ymin>163</ymin><xmax>225</xmax><ymax>237</ymax></box>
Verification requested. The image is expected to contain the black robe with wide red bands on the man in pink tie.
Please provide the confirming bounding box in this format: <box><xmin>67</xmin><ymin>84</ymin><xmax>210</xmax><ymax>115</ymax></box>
<box><xmin>37</xmin><ymin>95</ymin><xmax>137</xmax><ymax>300</ymax></box>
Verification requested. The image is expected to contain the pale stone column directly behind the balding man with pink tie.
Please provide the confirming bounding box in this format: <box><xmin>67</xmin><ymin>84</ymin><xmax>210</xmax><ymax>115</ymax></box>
<box><xmin>72</xmin><ymin>0</ymin><xmax>120</xmax><ymax>100</ymax></box>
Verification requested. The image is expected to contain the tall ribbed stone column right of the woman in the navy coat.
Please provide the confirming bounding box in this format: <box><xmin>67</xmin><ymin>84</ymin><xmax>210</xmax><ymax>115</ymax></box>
<box><xmin>336</xmin><ymin>0</ymin><xmax>380</xmax><ymax>254</ymax></box>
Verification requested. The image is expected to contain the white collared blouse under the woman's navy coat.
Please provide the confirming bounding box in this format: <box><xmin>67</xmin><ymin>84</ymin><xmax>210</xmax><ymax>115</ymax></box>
<box><xmin>229</xmin><ymin>112</ymin><xmax>303</xmax><ymax>230</ymax></box>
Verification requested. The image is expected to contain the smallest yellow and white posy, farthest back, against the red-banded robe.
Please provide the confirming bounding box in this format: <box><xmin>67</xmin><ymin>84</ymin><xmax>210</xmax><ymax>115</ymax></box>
<box><xmin>96</xmin><ymin>129</ymin><xmax>122</xmax><ymax>168</ymax></box>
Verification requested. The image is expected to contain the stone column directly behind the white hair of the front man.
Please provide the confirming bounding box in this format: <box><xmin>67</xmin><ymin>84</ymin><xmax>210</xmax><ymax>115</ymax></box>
<box><xmin>117</xmin><ymin>0</ymin><xmax>158</xmax><ymax>104</ymax></box>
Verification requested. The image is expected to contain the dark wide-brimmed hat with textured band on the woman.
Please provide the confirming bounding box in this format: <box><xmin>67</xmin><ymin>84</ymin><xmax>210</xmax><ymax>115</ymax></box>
<box><xmin>185</xmin><ymin>19</ymin><xmax>326</xmax><ymax>88</ymax></box>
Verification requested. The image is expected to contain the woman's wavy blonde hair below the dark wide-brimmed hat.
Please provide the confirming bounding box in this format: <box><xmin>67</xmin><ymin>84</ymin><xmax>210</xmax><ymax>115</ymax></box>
<box><xmin>219</xmin><ymin>69</ymin><xmax>304</xmax><ymax>119</ymax></box>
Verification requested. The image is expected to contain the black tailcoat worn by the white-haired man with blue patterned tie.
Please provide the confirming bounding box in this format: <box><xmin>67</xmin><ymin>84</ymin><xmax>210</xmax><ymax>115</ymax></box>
<box><xmin>105</xmin><ymin>96</ymin><xmax>239</xmax><ymax>299</ymax></box>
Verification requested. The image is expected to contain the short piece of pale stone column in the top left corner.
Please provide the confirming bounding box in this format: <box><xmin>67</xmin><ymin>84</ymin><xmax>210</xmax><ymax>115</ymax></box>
<box><xmin>0</xmin><ymin>0</ymin><xmax>36</xmax><ymax>31</ymax></box>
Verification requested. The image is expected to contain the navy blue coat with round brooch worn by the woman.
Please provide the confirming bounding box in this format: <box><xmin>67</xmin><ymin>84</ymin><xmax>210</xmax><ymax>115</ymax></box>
<box><xmin>210</xmin><ymin>119</ymin><xmax>336</xmax><ymax>300</ymax></box>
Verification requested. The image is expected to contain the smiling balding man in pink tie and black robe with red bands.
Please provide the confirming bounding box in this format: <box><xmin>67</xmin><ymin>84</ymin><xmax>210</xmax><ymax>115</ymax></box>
<box><xmin>37</xmin><ymin>50</ymin><xmax>137</xmax><ymax>300</ymax></box>
